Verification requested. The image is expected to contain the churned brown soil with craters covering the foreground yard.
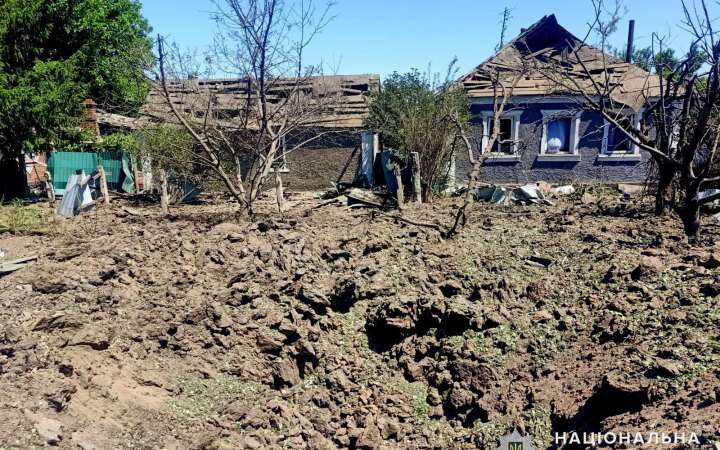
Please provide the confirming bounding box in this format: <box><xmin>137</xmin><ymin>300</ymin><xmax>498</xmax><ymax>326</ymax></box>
<box><xmin>0</xmin><ymin>194</ymin><xmax>720</xmax><ymax>450</ymax></box>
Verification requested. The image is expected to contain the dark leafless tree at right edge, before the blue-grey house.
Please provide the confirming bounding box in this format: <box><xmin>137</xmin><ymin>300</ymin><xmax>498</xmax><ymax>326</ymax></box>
<box><xmin>538</xmin><ymin>0</ymin><xmax>720</xmax><ymax>241</ymax></box>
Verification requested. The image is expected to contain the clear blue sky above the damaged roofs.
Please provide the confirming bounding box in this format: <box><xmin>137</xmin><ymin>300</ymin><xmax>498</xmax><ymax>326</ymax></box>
<box><xmin>141</xmin><ymin>0</ymin><xmax>689</xmax><ymax>77</ymax></box>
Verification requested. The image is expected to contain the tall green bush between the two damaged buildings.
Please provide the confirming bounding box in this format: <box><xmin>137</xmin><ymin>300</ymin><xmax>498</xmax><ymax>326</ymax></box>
<box><xmin>366</xmin><ymin>64</ymin><xmax>468</xmax><ymax>199</ymax></box>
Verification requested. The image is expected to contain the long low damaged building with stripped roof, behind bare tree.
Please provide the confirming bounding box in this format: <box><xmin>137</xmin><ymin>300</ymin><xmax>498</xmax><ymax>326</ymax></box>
<box><xmin>98</xmin><ymin>74</ymin><xmax>380</xmax><ymax>190</ymax></box>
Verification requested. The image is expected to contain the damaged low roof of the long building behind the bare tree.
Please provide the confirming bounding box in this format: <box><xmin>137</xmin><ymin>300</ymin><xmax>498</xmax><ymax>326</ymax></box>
<box><xmin>98</xmin><ymin>74</ymin><xmax>380</xmax><ymax>129</ymax></box>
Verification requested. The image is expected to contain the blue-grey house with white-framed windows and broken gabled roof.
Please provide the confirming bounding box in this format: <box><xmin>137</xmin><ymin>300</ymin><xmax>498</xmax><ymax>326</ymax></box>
<box><xmin>458</xmin><ymin>15</ymin><xmax>659</xmax><ymax>183</ymax></box>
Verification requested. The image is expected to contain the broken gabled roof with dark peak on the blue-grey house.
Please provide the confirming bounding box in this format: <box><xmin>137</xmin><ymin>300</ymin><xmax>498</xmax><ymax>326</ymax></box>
<box><xmin>461</xmin><ymin>15</ymin><xmax>660</xmax><ymax>110</ymax></box>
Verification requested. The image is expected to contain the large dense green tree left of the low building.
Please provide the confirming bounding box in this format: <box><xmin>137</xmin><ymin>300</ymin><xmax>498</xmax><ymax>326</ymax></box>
<box><xmin>0</xmin><ymin>0</ymin><xmax>153</xmax><ymax>194</ymax></box>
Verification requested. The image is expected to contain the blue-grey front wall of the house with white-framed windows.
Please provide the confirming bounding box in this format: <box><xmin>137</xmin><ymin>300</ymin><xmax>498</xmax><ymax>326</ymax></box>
<box><xmin>457</xmin><ymin>102</ymin><xmax>650</xmax><ymax>184</ymax></box>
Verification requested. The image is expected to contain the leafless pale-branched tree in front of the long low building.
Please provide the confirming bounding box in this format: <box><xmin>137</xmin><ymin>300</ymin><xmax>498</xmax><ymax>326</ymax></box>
<box><xmin>158</xmin><ymin>0</ymin><xmax>337</xmax><ymax>213</ymax></box>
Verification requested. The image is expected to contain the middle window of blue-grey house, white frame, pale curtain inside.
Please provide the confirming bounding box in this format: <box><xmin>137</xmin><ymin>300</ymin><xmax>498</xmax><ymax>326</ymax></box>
<box><xmin>538</xmin><ymin>110</ymin><xmax>581</xmax><ymax>161</ymax></box>
